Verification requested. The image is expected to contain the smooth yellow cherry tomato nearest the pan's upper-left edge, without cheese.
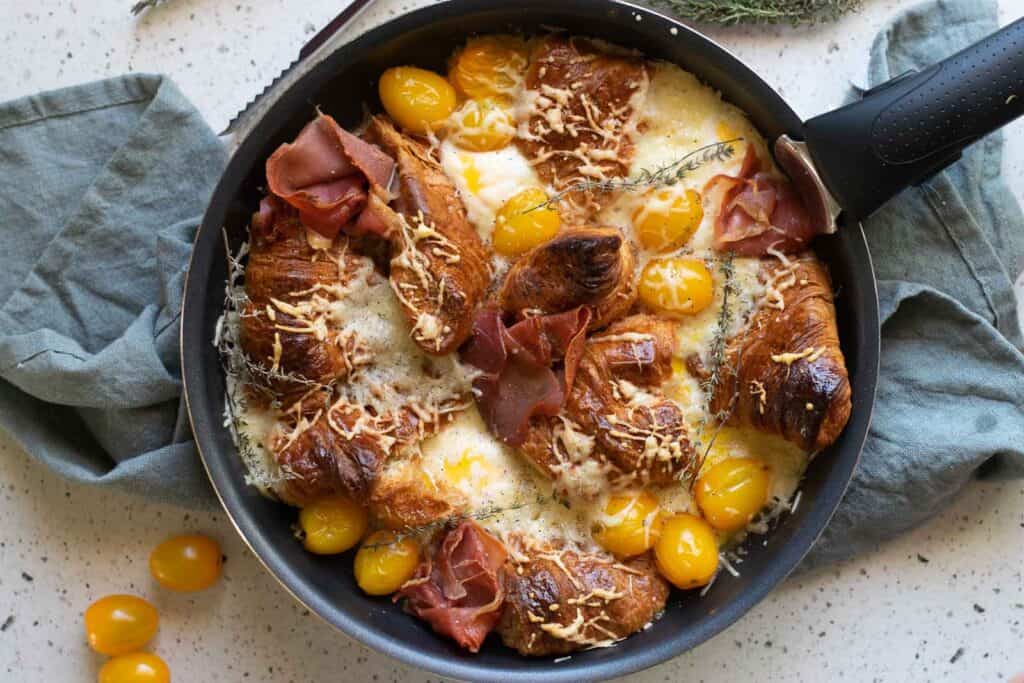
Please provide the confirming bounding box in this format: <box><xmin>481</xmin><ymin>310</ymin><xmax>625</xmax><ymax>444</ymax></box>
<box><xmin>378</xmin><ymin>67</ymin><xmax>457</xmax><ymax>133</ymax></box>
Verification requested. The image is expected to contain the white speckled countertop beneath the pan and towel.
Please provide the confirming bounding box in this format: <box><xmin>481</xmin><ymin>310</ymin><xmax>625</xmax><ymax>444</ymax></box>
<box><xmin>0</xmin><ymin>0</ymin><xmax>1024</xmax><ymax>683</ymax></box>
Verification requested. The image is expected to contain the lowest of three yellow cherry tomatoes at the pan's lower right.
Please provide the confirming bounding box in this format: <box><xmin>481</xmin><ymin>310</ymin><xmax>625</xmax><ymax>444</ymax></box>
<box><xmin>654</xmin><ymin>513</ymin><xmax>718</xmax><ymax>589</ymax></box>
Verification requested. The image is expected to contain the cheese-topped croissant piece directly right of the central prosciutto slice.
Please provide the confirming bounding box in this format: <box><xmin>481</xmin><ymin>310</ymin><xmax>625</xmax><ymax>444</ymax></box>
<box><xmin>520</xmin><ymin>314</ymin><xmax>698</xmax><ymax>498</ymax></box>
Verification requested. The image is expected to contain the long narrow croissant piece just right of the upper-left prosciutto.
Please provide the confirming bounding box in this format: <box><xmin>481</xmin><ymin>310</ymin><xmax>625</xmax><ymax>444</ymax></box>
<box><xmin>368</xmin><ymin>116</ymin><xmax>490</xmax><ymax>355</ymax></box>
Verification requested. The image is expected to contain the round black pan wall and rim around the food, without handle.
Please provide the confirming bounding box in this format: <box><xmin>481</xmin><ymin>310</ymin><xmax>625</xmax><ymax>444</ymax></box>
<box><xmin>181</xmin><ymin>0</ymin><xmax>879</xmax><ymax>682</ymax></box>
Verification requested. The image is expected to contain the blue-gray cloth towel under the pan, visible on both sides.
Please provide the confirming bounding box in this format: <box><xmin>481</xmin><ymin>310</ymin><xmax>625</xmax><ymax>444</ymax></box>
<box><xmin>0</xmin><ymin>0</ymin><xmax>1024</xmax><ymax>564</ymax></box>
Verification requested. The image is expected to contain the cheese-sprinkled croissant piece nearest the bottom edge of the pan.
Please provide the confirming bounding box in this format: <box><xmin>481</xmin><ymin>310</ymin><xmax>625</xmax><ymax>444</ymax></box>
<box><xmin>498</xmin><ymin>550</ymin><xmax>669</xmax><ymax>656</ymax></box>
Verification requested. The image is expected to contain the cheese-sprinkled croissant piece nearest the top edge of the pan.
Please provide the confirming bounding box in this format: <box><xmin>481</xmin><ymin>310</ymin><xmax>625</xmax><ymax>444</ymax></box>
<box><xmin>517</xmin><ymin>37</ymin><xmax>649</xmax><ymax>219</ymax></box>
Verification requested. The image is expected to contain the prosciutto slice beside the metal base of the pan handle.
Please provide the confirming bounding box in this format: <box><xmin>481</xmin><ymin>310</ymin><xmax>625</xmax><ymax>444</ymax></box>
<box><xmin>705</xmin><ymin>145</ymin><xmax>824</xmax><ymax>257</ymax></box>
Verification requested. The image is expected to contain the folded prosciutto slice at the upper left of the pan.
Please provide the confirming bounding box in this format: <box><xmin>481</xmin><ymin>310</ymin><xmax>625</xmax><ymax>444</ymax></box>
<box><xmin>266</xmin><ymin>114</ymin><xmax>394</xmax><ymax>238</ymax></box>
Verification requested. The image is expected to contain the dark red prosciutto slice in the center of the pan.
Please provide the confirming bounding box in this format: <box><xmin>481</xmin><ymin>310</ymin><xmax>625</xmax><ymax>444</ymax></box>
<box><xmin>463</xmin><ymin>306</ymin><xmax>591</xmax><ymax>445</ymax></box>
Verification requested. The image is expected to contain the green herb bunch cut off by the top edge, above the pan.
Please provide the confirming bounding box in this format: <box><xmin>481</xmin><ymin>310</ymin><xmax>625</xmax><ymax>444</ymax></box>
<box><xmin>650</xmin><ymin>0</ymin><xmax>862</xmax><ymax>26</ymax></box>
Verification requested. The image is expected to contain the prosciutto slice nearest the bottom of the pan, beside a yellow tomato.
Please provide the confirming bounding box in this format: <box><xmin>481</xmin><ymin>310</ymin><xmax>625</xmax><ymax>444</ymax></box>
<box><xmin>395</xmin><ymin>521</ymin><xmax>508</xmax><ymax>652</ymax></box>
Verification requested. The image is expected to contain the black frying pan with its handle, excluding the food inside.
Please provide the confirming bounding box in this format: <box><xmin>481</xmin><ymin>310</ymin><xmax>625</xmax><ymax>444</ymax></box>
<box><xmin>181</xmin><ymin>0</ymin><xmax>1024</xmax><ymax>682</ymax></box>
